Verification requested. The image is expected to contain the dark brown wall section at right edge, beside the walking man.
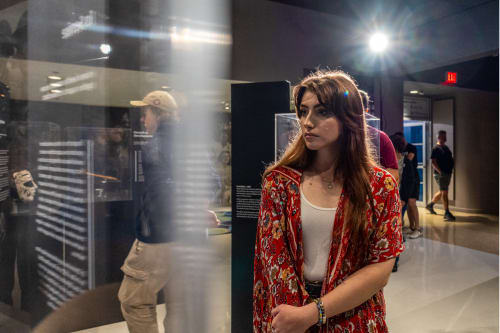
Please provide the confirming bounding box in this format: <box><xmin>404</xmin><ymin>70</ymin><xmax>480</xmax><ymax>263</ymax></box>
<box><xmin>453</xmin><ymin>89</ymin><xmax>499</xmax><ymax>214</ymax></box>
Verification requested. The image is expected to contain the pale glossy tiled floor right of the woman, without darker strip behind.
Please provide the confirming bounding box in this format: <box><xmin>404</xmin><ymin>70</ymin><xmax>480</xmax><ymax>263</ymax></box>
<box><xmin>384</xmin><ymin>238</ymin><xmax>499</xmax><ymax>333</ymax></box>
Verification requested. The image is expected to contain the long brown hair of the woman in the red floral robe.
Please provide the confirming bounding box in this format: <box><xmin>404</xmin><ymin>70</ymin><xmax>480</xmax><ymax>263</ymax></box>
<box><xmin>264</xmin><ymin>71</ymin><xmax>375</xmax><ymax>244</ymax></box>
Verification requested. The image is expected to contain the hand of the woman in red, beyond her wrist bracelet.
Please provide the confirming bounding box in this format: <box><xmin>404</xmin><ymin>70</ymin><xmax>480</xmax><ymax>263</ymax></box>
<box><xmin>271</xmin><ymin>303</ymin><xmax>318</xmax><ymax>333</ymax></box>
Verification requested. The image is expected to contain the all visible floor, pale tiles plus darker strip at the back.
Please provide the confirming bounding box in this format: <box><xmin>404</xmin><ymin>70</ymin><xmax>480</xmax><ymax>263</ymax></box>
<box><xmin>0</xmin><ymin>209</ymin><xmax>499</xmax><ymax>333</ymax></box>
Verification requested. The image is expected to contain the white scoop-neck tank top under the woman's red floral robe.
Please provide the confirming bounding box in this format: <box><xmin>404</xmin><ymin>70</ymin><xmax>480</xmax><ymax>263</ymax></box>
<box><xmin>300</xmin><ymin>192</ymin><xmax>337</xmax><ymax>281</ymax></box>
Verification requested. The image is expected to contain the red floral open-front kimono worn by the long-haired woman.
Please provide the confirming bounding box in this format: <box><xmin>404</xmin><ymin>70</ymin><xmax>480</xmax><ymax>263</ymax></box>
<box><xmin>253</xmin><ymin>167</ymin><xmax>404</xmax><ymax>333</ymax></box>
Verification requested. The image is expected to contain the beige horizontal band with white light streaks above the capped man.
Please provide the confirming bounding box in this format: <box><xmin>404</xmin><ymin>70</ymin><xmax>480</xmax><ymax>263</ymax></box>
<box><xmin>0</xmin><ymin>58</ymin><xmax>243</xmax><ymax>107</ymax></box>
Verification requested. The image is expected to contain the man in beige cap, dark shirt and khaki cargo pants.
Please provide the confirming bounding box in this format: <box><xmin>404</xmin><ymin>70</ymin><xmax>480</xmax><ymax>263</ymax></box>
<box><xmin>118</xmin><ymin>91</ymin><xmax>183</xmax><ymax>333</ymax></box>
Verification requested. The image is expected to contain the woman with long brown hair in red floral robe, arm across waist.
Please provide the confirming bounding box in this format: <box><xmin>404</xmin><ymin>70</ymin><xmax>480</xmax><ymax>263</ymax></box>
<box><xmin>253</xmin><ymin>71</ymin><xmax>404</xmax><ymax>333</ymax></box>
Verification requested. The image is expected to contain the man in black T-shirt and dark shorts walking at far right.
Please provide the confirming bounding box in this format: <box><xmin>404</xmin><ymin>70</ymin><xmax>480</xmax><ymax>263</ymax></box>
<box><xmin>425</xmin><ymin>131</ymin><xmax>455</xmax><ymax>221</ymax></box>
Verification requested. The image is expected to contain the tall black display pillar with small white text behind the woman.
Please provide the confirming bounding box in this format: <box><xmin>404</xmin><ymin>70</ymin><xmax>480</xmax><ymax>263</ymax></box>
<box><xmin>231</xmin><ymin>81</ymin><xmax>290</xmax><ymax>332</ymax></box>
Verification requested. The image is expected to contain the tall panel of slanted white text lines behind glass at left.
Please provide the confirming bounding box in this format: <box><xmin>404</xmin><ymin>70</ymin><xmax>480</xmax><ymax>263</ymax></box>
<box><xmin>35</xmin><ymin>141</ymin><xmax>95</xmax><ymax>309</ymax></box>
